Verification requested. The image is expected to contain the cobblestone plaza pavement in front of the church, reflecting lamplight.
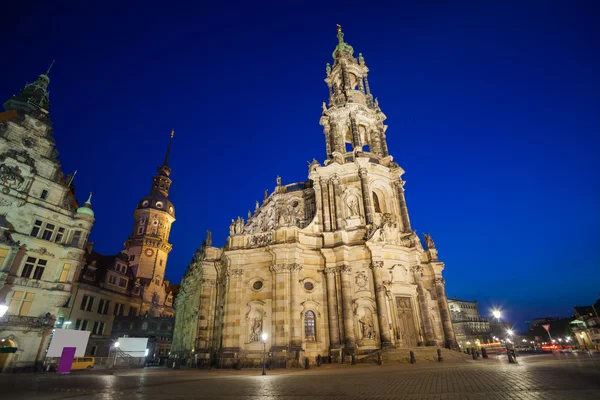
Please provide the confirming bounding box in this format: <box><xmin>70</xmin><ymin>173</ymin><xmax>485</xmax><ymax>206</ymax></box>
<box><xmin>0</xmin><ymin>354</ymin><xmax>600</xmax><ymax>400</ymax></box>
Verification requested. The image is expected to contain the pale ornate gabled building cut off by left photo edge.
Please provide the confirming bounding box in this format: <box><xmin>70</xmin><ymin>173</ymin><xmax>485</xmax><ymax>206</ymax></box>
<box><xmin>0</xmin><ymin>66</ymin><xmax>94</xmax><ymax>372</ymax></box>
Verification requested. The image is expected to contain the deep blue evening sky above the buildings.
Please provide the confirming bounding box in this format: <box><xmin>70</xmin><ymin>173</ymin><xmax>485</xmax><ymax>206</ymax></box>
<box><xmin>0</xmin><ymin>0</ymin><xmax>600</xmax><ymax>326</ymax></box>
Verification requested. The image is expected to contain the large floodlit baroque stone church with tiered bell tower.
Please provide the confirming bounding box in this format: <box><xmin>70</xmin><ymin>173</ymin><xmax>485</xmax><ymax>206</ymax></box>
<box><xmin>172</xmin><ymin>28</ymin><xmax>457</xmax><ymax>367</ymax></box>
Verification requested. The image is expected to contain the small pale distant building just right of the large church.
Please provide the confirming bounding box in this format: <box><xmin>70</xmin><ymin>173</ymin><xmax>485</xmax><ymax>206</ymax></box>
<box><xmin>448</xmin><ymin>297</ymin><xmax>492</xmax><ymax>348</ymax></box>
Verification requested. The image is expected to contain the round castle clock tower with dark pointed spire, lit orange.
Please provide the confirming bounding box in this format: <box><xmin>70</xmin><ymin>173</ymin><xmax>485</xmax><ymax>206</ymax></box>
<box><xmin>125</xmin><ymin>131</ymin><xmax>175</xmax><ymax>290</ymax></box>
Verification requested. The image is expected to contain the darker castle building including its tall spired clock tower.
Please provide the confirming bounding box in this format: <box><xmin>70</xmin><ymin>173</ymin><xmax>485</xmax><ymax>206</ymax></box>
<box><xmin>57</xmin><ymin>135</ymin><xmax>175</xmax><ymax>357</ymax></box>
